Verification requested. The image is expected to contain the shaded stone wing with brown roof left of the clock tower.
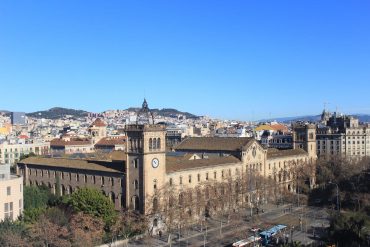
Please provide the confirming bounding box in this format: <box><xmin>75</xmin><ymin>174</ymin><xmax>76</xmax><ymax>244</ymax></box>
<box><xmin>17</xmin><ymin>157</ymin><xmax>127</xmax><ymax>210</ymax></box>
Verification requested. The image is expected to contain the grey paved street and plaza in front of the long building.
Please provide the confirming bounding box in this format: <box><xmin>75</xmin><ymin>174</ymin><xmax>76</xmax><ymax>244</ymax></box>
<box><xmin>118</xmin><ymin>204</ymin><xmax>329</xmax><ymax>247</ymax></box>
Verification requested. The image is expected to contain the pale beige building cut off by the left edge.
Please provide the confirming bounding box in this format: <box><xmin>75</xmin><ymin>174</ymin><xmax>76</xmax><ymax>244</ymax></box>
<box><xmin>0</xmin><ymin>165</ymin><xmax>23</xmax><ymax>221</ymax></box>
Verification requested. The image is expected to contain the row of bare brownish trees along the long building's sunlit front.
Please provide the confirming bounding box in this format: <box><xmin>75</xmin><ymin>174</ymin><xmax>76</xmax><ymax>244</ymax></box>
<box><xmin>147</xmin><ymin>161</ymin><xmax>315</xmax><ymax>244</ymax></box>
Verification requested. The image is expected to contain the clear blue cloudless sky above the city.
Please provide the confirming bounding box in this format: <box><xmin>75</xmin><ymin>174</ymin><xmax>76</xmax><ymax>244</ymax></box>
<box><xmin>0</xmin><ymin>0</ymin><xmax>370</xmax><ymax>120</ymax></box>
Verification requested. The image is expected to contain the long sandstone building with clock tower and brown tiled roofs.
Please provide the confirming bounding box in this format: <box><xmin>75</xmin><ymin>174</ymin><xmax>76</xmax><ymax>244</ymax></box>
<box><xmin>18</xmin><ymin>102</ymin><xmax>316</xmax><ymax>232</ymax></box>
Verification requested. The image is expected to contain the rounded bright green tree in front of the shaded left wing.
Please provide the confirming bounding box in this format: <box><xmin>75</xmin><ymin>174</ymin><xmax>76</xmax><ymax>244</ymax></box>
<box><xmin>67</xmin><ymin>188</ymin><xmax>117</xmax><ymax>227</ymax></box>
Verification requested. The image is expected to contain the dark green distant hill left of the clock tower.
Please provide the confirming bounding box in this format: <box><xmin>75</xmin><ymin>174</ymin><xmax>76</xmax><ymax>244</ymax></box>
<box><xmin>26</xmin><ymin>107</ymin><xmax>88</xmax><ymax>119</ymax></box>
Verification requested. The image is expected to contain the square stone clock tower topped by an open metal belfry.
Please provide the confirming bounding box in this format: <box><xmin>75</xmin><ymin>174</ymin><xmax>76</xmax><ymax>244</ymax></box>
<box><xmin>125</xmin><ymin>100</ymin><xmax>166</xmax><ymax>214</ymax></box>
